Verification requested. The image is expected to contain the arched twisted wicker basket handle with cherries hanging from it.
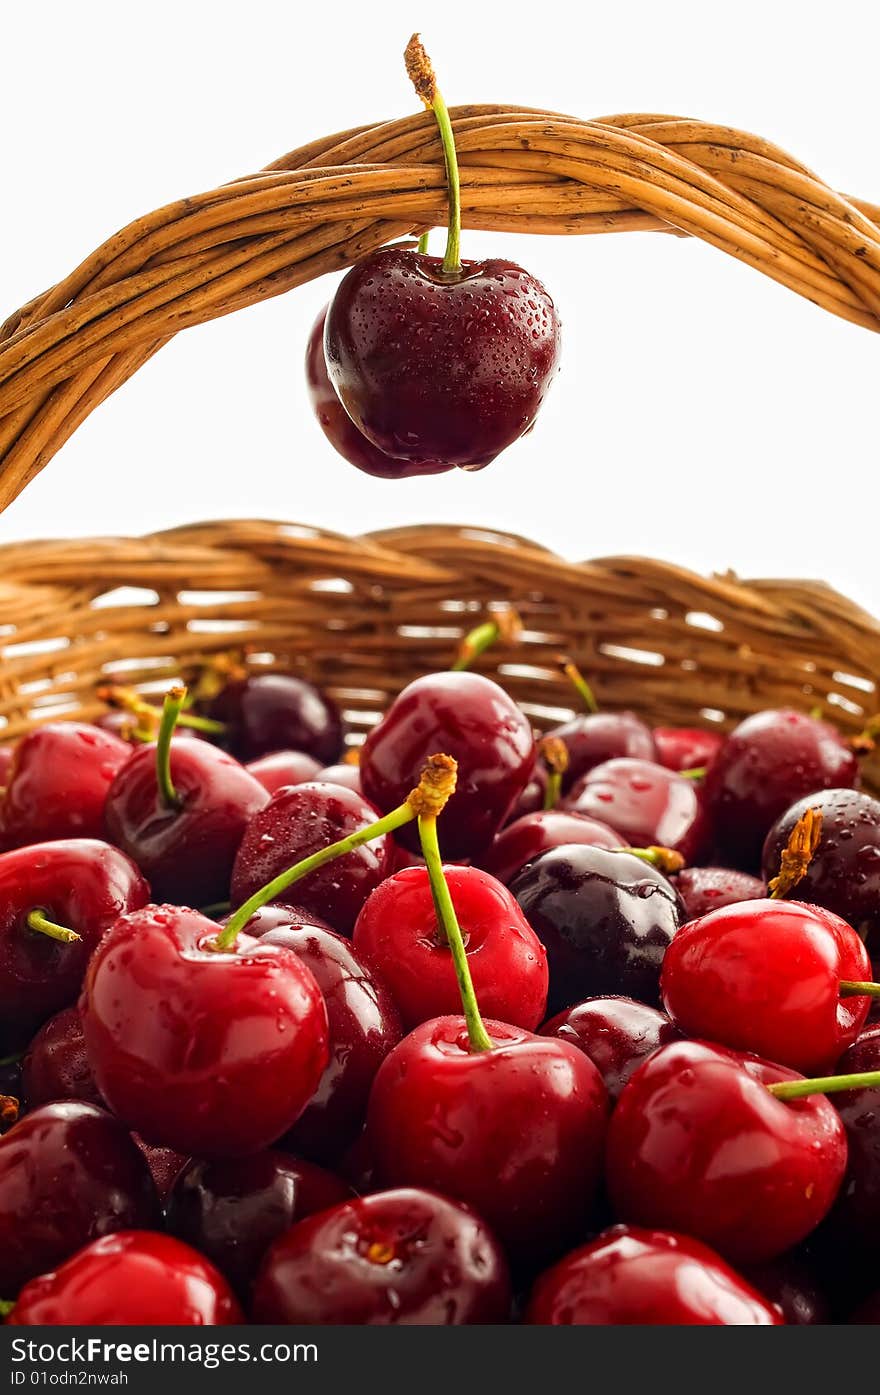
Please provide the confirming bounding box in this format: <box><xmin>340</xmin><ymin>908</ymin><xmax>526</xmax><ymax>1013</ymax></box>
<box><xmin>0</xmin><ymin>106</ymin><xmax>880</xmax><ymax>511</ymax></box>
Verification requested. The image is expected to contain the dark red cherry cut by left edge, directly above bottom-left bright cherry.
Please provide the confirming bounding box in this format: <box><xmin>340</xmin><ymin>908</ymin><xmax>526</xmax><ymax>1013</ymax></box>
<box><xmin>0</xmin><ymin>1101</ymin><xmax>159</xmax><ymax>1299</ymax></box>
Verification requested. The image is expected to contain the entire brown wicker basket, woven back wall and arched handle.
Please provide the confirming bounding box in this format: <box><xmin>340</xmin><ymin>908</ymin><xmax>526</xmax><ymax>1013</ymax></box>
<box><xmin>0</xmin><ymin>106</ymin><xmax>880</xmax><ymax>785</ymax></box>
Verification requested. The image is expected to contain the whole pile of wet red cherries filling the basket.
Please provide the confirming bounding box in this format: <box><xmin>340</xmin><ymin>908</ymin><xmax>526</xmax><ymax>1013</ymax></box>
<box><xmin>0</xmin><ymin>621</ymin><xmax>880</xmax><ymax>1325</ymax></box>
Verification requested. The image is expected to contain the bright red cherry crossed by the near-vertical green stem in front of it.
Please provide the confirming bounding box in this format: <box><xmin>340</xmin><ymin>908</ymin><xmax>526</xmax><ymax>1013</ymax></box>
<box><xmin>353</xmin><ymin>866</ymin><xmax>549</xmax><ymax>1031</ymax></box>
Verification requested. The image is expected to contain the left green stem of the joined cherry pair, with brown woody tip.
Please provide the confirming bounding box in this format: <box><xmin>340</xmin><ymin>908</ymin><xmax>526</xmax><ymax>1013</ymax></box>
<box><xmin>212</xmin><ymin>755</ymin><xmax>459</xmax><ymax>953</ymax></box>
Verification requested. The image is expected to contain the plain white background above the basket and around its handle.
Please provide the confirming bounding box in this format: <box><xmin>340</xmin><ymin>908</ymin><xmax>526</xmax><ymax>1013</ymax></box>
<box><xmin>0</xmin><ymin>0</ymin><xmax>880</xmax><ymax>612</ymax></box>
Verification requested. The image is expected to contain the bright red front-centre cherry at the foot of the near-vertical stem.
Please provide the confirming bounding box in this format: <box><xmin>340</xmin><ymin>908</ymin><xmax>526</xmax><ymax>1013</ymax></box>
<box><xmin>367</xmin><ymin>1017</ymin><xmax>608</xmax><ymax>1260</ymax></box>
